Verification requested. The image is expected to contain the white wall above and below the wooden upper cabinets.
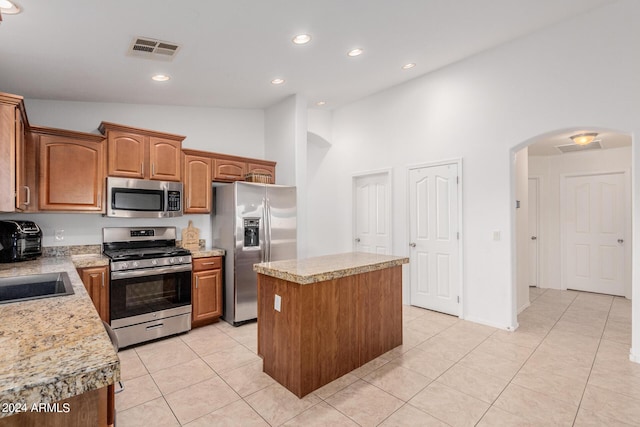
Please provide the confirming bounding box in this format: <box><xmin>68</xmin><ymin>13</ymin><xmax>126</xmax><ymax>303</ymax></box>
<box><xmin>0</xmin><ymin>99</ymin><xmax>264</xmax><ymax>246</ymax></box>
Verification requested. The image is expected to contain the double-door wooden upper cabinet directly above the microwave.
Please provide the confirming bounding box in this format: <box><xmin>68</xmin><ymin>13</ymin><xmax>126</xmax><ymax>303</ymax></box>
<box><xmin>98</xmin><ymin>122</ymin><xmax>185</xmax><ymax>181</ymax></box>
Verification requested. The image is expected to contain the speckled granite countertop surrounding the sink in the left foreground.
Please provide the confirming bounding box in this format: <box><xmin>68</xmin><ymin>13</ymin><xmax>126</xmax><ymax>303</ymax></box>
<box><xmin>0</xmin><ymin>257</ymin><xmax>120</xmax><ymax>417</ymax></box>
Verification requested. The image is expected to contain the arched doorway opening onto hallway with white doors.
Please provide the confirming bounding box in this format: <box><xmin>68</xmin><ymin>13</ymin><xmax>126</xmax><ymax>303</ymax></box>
<box><xmin>512</xmin><ymin>128</ymin><xmax>633</xmax><ymax>338</ymax></box>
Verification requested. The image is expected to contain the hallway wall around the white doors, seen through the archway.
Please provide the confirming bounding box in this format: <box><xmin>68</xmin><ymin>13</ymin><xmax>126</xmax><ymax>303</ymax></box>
<box><xmin>529</xmin><ymin>147</ymin><xmax>632</xmax><ymax>296</ymax></box>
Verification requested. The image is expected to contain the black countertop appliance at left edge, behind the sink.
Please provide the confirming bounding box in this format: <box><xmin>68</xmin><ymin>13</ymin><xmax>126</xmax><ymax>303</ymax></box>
<box><xmin>0</xmin><ymin>220</ymin><xmax>42</xmax><ymax>263</ymax></box>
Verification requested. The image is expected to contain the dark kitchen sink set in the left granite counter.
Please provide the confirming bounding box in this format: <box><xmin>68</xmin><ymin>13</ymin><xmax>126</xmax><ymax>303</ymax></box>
<box><xmin>0</xmin><ymin>272</ymin><xmax>73</xmax><ymax>304</ymax></box>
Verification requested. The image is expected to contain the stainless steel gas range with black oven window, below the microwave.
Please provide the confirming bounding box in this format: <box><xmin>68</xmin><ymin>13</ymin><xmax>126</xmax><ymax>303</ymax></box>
<box><xmin>102</xmin><ymin>227</ymin><xmax>191</xmax><ymax>347</ymax></box>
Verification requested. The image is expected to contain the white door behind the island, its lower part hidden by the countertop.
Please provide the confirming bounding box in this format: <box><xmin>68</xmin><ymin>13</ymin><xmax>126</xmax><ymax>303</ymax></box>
<box><xmin>353</xmin><ymin>172</ymin><xmax>391</xmax><ymax>255</ymax></box>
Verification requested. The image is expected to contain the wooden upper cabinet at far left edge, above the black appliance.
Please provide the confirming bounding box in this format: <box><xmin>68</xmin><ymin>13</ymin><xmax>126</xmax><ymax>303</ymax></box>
<box><xmin>0</xmin><ymin>93</ymin><xmax>33</xmax><ymax>212</ymax></box>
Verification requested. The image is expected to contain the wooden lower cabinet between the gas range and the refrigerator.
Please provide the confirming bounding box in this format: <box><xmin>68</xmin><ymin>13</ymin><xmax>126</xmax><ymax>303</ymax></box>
<box><xmin>191</xmin><ymin>257</ymin><xmax>222</xmax><ymax>327</ymax></box>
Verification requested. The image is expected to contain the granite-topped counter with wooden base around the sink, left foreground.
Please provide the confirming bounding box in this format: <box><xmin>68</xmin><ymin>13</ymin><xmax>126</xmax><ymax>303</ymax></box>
<box><xmin>0</xmin><ymin>255</ymin><xmax>120</xmax><ymax>426</ymax></box>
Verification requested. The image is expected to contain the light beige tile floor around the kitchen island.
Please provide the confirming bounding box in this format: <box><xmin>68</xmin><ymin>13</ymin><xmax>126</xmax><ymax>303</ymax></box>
<box><xmin>116</xmin><ymin>288</ymin><xmax>640</xmax><ymax>427</ymax></box>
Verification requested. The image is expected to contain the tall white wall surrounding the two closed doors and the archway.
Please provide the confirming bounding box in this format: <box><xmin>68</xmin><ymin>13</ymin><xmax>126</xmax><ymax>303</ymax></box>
<box><xmin>309</xmin><ymin>0</ymin><xmax>640</xmax><ymax>338</ymax></box>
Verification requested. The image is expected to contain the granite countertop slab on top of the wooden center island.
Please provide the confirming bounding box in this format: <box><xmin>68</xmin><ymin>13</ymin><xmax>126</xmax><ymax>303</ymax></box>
<box><xmin>253</xmin><ymin>252</ymin><xmax>409</xmax><ymax>285</ymax></box>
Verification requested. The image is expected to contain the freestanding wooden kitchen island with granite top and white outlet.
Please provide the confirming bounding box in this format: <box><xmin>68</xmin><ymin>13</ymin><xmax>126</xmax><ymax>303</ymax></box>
<box><xmin>254</xmin><ymin>252</ymin><xmax>409</xmax><ymax>397</ymax></box>
